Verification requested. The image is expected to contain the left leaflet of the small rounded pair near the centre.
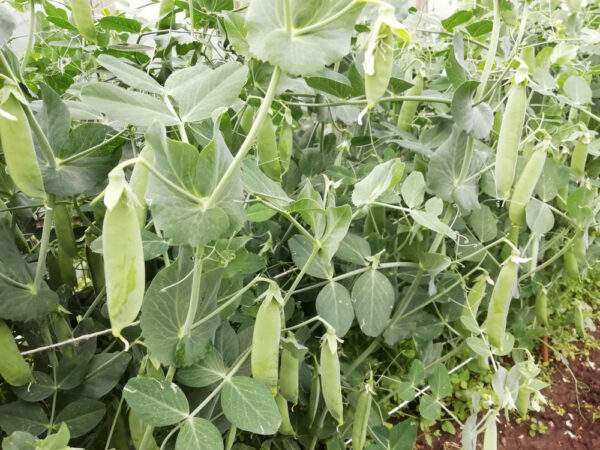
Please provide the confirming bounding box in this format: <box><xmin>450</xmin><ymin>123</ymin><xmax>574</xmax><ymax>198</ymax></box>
<box><xmin>316</xmin><ymin>281</ymin><xmax>354</xmax><ymax>337</ymax></box>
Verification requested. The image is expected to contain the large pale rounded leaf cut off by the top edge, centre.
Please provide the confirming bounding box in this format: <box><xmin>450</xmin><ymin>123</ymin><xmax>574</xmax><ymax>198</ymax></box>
<box><xmin>246</xmin><ymin>0</ymin><xmax>363</xmax><ymax>75</ymax></box>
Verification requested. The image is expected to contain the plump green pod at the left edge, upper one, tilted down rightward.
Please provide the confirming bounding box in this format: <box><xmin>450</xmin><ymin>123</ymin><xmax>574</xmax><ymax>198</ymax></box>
<box><xmin>0</xmin><ymin>95</ymin><xmax>46</xmax><ymax>199</ymax></box>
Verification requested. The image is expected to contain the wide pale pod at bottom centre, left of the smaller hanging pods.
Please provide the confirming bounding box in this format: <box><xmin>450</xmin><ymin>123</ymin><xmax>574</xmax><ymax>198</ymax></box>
<box><xmin>250</xmin><ymin>298</ymin><xmax>281</xmax><ymax>395</ymax></box>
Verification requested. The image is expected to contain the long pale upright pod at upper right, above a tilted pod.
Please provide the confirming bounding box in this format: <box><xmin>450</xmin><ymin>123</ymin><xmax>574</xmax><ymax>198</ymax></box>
<box><xmin>495</xmin><ymin>83</ymin><xmax>527</xmax><ymax>199</ymax></box>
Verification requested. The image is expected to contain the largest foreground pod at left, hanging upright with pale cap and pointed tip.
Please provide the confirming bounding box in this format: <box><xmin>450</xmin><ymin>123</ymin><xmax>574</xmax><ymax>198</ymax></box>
<box><xmin>102</xmin><ymin>168</ymin><xmax>145</xmax><ymax>337</ymax></box>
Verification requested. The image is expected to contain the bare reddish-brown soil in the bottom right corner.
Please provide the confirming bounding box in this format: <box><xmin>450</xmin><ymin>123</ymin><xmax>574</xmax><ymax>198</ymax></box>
<box><xmin>417</xmin><ymin>332</ymin><xmax>600</xmax><ymax>450</ymax></box>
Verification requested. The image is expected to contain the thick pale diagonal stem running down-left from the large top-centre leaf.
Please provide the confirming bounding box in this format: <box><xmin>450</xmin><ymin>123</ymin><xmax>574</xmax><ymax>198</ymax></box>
<box><xmin>207</xmin><ymin>66</ymin><xmax>282</xmax><ymax>208</ymax></box>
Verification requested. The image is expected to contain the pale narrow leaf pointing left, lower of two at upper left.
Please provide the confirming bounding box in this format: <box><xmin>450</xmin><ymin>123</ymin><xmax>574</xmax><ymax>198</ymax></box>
<box><xmin>81</xmin><ymin>83</ymin><xmax>179</xmax><ymax>127</ymax></box>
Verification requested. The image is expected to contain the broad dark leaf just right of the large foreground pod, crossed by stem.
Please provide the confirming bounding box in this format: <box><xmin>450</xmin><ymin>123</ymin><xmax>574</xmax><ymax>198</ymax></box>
<box><xmin>141</xmin><ymin>255</ymin><xmax>221</xmax><ymax>366</ymax></box>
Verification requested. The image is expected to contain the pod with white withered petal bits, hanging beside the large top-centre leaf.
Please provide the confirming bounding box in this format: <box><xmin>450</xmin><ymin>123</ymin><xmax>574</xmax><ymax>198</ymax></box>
<box><xmin>365</xmin><ymin>23</ymin><xmax>394</xmax><ymax>109</ymax></box>
